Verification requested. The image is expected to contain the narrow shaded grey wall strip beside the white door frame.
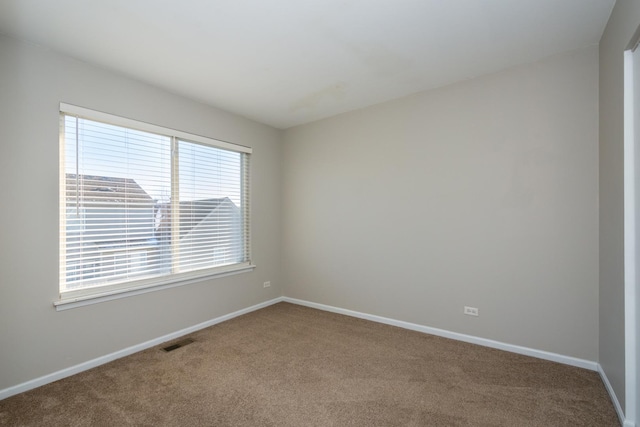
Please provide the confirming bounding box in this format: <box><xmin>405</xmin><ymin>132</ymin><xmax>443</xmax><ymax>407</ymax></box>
<box><xmin>599</xmin><ymin>0</ymin><xmax>640</xmax><ymax>416</ymax></box>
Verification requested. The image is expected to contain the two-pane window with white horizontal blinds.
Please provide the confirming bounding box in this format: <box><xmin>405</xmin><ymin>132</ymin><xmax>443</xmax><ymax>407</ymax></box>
<box><xmin>60</xmin><ymin>104</ymin><xmax>253</xmax><ymax>304</ymax></box>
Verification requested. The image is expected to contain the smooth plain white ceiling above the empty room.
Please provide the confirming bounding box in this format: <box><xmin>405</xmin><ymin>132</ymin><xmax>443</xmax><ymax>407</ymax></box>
<box><xmin>0</xmin><ymin>0</ymin><xmax>615</xmax><ymax>128</ymax></box>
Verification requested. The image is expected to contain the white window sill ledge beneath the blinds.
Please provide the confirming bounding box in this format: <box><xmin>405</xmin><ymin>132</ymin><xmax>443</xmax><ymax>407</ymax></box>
<box><xmin>53</xmin><ymin>265</ymin><xmax>256</xmax><ymax>311</ymax></box>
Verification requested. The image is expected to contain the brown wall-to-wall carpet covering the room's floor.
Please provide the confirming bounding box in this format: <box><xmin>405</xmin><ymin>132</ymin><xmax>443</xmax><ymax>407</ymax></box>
<box><xmin>0</xmin><ymin>303</ymin><xmax>619</xmax><ymax>427</ymax></box>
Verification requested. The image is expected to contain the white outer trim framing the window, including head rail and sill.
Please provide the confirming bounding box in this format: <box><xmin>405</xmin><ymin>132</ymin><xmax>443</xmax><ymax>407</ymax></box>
<box><xmin>53</xmin><ymin>102</ymin><xmax>256</xmax><ymax>311</ymax></box>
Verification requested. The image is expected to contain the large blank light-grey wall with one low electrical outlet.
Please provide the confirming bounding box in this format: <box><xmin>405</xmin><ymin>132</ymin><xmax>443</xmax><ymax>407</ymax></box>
<box><xmin>283</xmin><ymin>46</ymin><xmax>598</xmax><ymax>361</ymax></box>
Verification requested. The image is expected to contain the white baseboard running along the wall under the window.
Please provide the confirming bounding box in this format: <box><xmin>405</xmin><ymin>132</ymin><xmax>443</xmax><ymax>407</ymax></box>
<box><xmin>0</xmin><ymin>297</ymin><xmax>283</xmax><ymax>400</ymax></box>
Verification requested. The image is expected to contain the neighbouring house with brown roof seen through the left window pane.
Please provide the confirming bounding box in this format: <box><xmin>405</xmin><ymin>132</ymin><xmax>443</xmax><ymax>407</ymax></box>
<box><xmin>66</xmin><ymin>174</ymin><xmax>162</xmax><ymax>288</ymax></box>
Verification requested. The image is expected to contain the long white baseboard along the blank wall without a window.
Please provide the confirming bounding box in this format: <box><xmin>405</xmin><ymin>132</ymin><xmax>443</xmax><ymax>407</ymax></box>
<box><xmin>283</xmin><ymin>297</ymin><xmax>598</xmax><ymax>371</ymax></box>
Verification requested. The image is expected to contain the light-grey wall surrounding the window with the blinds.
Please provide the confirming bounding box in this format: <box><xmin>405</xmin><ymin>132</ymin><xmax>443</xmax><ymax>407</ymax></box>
<box><xmin>0</xmin><ymin>36</ymin><xmax>282</xmax><ymax>390</ymax></box>
